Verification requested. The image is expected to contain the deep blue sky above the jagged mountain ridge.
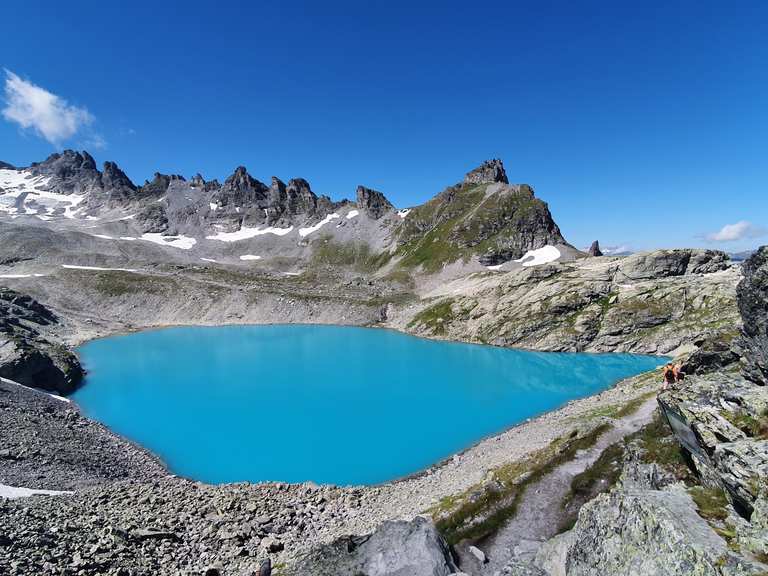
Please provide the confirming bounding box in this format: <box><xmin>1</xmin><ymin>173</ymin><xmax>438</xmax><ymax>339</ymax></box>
<box><xmin>0</xmin><ymin>0</ymin><xmax>768</xmax><ymax>250</ymax></box>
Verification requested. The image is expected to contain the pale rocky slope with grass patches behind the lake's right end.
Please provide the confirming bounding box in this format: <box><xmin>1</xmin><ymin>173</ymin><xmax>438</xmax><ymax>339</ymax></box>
<box><xmin>391</xmin><ymin>249</ymin><xmax>740</xmax><ymax>354</ymax></box>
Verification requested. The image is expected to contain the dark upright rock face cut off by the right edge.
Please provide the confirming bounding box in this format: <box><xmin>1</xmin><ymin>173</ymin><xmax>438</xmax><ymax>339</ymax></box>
<box><xmin>736</xmin><ymin>246</ymin><xmax>768</xmax><ymax>384</ymax></box>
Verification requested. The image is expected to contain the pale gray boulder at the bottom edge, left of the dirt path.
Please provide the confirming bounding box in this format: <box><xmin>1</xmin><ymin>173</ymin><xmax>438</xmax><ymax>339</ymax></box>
<box><xmin>290</xmin><ymin>517</ymin><xmax>456</xmax><ymax>576</ymax></box>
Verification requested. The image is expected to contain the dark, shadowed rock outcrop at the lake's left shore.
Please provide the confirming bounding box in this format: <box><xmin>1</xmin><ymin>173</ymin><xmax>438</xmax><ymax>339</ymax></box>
<box><xmin>0</xmin><ymin>287</ymin><xmax>83</xmax><ymax>394</ymax></box>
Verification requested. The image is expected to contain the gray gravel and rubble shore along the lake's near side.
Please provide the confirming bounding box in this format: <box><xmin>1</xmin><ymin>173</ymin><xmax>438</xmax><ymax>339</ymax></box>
<box><xmin>0</xmin><ymin>366</ymin><xmax>656</xmax><ymax>576</ymax></box>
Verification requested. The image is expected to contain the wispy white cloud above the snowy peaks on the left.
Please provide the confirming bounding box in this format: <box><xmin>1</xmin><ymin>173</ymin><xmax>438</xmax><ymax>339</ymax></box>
<box><xmin>2</xmin><ymin>70</ymin><xmax>95</xmax><ymax>146</ymax></box>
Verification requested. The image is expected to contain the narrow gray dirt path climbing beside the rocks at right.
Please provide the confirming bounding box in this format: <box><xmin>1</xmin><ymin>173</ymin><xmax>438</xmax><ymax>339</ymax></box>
<box><xmin>458</xmin><ymin>397</ymin><xmax>657</xmax><ymax>576</ymax></box>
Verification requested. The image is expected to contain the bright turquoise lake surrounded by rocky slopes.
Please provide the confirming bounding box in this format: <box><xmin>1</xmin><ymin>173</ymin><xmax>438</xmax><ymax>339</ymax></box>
<box><xmin>73</xmin><ymin>325</ymin><xmax>664</xmax><ymax>485</ymax></box>
